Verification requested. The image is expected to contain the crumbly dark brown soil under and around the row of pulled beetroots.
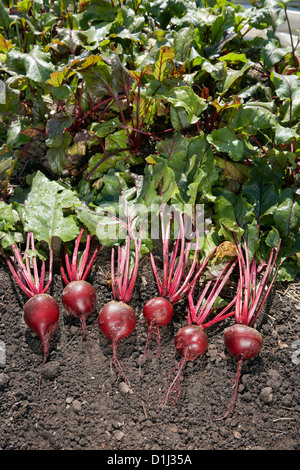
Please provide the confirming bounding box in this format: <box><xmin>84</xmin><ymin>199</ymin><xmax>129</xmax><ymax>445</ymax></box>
<box><xmin>0</xmin><ymin>253</ymin><xmax>300</xmax><ymax>451</ymax></box>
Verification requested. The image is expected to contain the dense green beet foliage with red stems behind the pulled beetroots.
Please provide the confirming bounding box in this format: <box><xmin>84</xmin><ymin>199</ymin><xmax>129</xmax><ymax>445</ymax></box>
<box><xmin>0</xmin><ymin>0</ymin><xmax>300</xmax><ymax>422</ymax></box>
